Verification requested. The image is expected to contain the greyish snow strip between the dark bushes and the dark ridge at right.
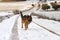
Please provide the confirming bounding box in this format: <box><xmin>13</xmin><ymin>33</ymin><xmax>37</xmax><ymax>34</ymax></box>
<box><xmin>35</xmin><ymin>11</ymin><xmax>60</xmax><ymax>20</ymax></box>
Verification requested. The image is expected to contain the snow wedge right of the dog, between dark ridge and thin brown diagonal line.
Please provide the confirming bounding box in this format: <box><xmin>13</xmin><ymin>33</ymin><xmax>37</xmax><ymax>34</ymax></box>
<box><xmin>35</xmin><ymin>19</ymin><xmax>60</xmax><ymax>34</ymax></box>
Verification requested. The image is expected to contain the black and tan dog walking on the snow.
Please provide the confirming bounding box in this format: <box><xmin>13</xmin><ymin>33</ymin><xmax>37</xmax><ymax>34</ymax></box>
<box><xmin>20</xmin><ymin>11</ymin><xmax>32</xmax><ymax>30</ymax></box>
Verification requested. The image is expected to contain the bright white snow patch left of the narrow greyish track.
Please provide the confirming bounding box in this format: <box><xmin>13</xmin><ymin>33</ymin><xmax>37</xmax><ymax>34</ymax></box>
<box><xmin>0</xmin><ymin>16</ymin><xmax>17</xmax><ymax>40</ymax></box>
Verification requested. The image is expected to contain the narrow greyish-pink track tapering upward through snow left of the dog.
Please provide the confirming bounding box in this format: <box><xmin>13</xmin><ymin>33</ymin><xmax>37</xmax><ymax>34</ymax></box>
<box><xmin>9</xmin><ymin>14</ymin><xmax>19</xmax><ymax>40</ymax></box>
